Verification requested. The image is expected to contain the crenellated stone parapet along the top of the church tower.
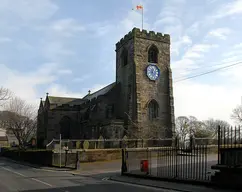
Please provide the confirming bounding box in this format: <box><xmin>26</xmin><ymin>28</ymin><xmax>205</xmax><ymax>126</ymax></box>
<box><xmin>116</xmin><ymin>28</ymin><xmax>170</xmax><ymax>50</ymax></box>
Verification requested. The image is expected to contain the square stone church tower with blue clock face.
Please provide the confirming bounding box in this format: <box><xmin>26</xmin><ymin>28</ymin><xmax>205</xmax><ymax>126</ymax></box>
<box><xmin>116</xmin><ymin>28</ymin><xmax>175</xmax><ymax>138</ymax></box>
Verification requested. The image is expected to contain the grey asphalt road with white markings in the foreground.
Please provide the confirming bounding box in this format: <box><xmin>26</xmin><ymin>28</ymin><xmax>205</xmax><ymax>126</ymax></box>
<box><xmin>0</xmin><ymin>157</ymin><xmax>176</xmax><ymax>192</ymax></box>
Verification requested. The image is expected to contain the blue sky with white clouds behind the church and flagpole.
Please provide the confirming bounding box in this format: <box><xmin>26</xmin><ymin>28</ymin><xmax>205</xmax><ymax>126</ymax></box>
<box><xmin>0</xmin><ymin>0</ymin><xmax>242</xmax><ymax>123</ymax></box>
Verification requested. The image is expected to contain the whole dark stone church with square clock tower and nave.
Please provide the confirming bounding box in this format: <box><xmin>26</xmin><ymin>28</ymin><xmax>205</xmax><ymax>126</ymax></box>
<box><xmin>37</xmin><ymin>28</ymin><xmax>175</xmax><ymax>146</ymax></box>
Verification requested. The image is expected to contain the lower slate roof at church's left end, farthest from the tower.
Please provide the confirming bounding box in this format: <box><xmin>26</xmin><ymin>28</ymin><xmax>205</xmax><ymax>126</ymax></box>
<box><xmin>48</xmin><ymin>96</ymin><xmax>84</xmax><ymax>105</ymax></box>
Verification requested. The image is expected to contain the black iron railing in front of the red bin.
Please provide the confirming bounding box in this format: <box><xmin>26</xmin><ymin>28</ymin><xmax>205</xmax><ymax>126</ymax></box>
<box><xmin>122</xmin><ymin>141</ymin><xmax>217</xmax><ymax>183</ymax></box>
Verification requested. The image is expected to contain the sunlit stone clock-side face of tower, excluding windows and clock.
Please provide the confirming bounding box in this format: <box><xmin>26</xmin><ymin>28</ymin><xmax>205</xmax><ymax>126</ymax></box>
<box><xmin>135</xmin><ymin>34</ymin><xmax>174</xmax><ymax>136</ymax></box>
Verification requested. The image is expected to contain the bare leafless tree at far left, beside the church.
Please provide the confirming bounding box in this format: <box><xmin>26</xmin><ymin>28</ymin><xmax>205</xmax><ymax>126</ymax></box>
<box><xmin>0</xmin><ymin>97</ymin><xmax>37</xmax><ymax>149</ymax></box>
